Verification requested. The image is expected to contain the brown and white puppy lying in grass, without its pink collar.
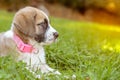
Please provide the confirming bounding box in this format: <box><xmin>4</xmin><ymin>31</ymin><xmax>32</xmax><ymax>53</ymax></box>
<box><xmin>0</xmin><ymin>7</ymin><xmax>60</xmax><ymax>78</ymax></box>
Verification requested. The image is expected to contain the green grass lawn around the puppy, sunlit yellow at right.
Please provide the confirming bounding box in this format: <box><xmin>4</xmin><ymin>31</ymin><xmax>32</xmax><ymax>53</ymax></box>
<box><xmin>0</xmin><ymin>11</ymin><xmax>120</xmax><ymax>80</ymax></box>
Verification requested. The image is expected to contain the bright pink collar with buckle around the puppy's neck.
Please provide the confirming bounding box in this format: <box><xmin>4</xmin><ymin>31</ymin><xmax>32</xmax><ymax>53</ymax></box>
<box><xmin>13</xmin><ymin>34</ymin><xmax>34</xmax><ymax>53</ymax></box>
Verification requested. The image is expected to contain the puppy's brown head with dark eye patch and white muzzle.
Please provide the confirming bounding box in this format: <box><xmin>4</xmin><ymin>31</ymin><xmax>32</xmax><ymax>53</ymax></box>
<box><xmin>13</xmin><ymin>7</ymin><xmax>58</xmax><ymax>44</ymax></box>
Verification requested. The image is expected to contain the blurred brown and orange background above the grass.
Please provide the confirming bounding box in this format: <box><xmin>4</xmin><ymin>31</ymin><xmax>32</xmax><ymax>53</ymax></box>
<box><xmin>0</xmin><ymin>0</ymin><xmax>120</xmax><ymax>25</ymax></box>
